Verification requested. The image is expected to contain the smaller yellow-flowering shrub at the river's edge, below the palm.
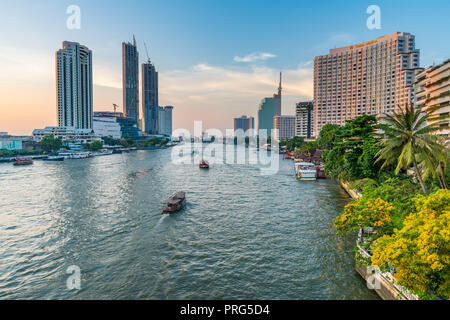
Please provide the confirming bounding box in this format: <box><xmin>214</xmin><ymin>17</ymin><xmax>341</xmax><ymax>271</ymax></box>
<box><xmin>334</xmin><ymin>198</ymin><xmax>395</xmax><ymax>234</ymax></box>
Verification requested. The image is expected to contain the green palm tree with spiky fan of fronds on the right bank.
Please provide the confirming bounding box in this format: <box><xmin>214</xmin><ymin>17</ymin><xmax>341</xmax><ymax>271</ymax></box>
<box><xmin>377</xmin><ymin>104</ymin><xmax>445</xmax><ymax>194</ymax></box>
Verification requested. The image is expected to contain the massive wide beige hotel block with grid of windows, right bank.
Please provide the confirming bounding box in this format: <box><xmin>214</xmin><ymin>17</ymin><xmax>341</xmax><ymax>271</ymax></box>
<box><xmin>314</xmin><ymin>32</ymin><xmax>421</xmax><ymax>136</ymax></box>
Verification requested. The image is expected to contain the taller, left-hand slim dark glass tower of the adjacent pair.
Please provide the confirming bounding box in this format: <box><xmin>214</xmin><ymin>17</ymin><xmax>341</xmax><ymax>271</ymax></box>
<box><xmin>122</xmin><ymin>36</ymin><xmax>139</xmax><ymax>123</ymax></box>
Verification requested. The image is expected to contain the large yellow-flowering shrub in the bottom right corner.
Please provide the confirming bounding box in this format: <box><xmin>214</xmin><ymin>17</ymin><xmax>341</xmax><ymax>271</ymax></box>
<box><xmin>372</xmin><ymin>190</ymin><xmax>450</xmax><ymax>299</ymax></box>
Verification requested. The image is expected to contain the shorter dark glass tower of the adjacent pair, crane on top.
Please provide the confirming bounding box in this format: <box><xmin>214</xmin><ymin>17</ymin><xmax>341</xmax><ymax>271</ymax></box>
<box><xmin>142</xmin><ymin>60</ymin><xmax>159</xmax><ymax>134</ymax></box>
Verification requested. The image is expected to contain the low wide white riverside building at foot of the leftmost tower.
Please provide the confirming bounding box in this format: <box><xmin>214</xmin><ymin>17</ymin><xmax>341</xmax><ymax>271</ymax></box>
<box><xmin>33</xmin><ymin>127</ymin><xmax>102</xmax><ymax>144</ymax></box>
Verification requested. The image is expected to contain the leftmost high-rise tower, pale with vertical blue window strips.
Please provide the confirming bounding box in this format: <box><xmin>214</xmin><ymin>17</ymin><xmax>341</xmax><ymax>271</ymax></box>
<box><xmin>56</xmin><ymin>41</ymin><xmax>93</xmax><ymax>129</ymax></box>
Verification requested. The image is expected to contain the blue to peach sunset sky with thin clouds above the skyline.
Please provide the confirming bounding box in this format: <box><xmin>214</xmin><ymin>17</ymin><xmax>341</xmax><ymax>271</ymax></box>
<box><xmin>0</xmin><ymin>0</ymin><xmax>450</xmax><ymax>135</ymax></box>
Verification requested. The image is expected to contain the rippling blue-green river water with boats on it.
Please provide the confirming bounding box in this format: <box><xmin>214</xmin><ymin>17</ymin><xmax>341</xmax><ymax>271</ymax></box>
<box><xmin>0</xmin><ymin>149</ymin><xmax>377</xmax><ymax>299</ymax></box>
